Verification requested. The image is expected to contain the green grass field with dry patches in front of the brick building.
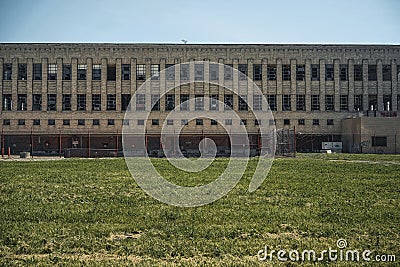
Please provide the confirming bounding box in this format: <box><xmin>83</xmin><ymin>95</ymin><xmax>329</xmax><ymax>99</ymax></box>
<box><xmin>0</xmin><ymin>154</ymin><xmax>400</xmax><ymax>266</ymax></box>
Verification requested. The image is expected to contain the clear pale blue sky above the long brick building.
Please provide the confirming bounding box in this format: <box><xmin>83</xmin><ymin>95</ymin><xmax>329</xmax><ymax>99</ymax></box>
<box><xmin>0</xmin><ymin>0</ymin><xmax>400</xmax><ymax>44</ymax></box>
